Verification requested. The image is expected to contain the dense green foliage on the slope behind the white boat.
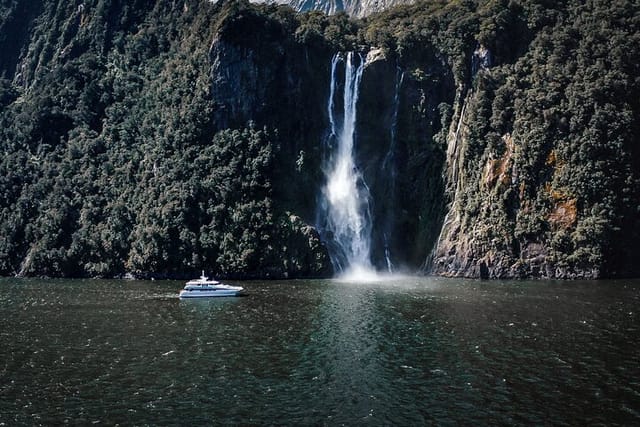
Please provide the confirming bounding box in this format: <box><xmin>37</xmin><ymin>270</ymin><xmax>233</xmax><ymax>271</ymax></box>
<box><xmin>0</xmin><ymin>1</ymin><xmax>328</xmax><ymax>277</ymax></box>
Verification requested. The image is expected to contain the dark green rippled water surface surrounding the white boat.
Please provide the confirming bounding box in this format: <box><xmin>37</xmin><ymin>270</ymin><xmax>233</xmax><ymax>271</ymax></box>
<box><xmin>0</xmin><ymin>278</ymin><xmax>640</xmax><ymax>426</ymax></box>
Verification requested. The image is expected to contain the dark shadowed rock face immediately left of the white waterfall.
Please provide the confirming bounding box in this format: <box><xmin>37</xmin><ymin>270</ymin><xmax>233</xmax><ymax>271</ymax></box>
<box><xmin>209</xmin><ymin>5</ymin><xmax>331</xmax><ymax>223</ymax></box>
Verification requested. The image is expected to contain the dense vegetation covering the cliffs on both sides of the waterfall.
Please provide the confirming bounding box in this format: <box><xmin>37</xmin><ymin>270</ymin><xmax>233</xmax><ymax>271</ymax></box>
<box><xmin>0</xmin><ymin>0</ymin><xmax>640</xmax><ymax>277</ymax></box>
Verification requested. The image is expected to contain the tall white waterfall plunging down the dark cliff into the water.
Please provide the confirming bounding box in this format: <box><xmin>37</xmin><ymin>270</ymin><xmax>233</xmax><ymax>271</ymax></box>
<box><xmin>318</xmin><ymin>52</ymin><xmax>373</xmax><ymax>273</ymax></box>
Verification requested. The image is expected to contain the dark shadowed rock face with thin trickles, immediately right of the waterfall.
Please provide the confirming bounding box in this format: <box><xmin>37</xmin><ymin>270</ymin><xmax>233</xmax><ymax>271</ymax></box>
<box><xmin>357</xmin><ymin>49</ymin><xmax>454</xmax><ymax>270</ymax></box>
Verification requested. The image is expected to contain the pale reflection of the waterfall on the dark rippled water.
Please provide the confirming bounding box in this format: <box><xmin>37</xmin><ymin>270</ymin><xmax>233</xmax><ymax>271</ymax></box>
<box><xmin>301</xmin><ymin>282</ymin><xmax>384</xmax><ymax>423</ymax></box>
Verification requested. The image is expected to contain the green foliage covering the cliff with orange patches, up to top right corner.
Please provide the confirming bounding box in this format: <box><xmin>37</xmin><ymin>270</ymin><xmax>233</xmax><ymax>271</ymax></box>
<box><xmin>444</xmin><ymin>1</ymin><xmax>640</xmax><ymax>277</ymax></box>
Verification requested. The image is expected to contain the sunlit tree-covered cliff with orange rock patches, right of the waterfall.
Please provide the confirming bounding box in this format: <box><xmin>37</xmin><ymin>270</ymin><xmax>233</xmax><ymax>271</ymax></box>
<box><xmin>431</xmin><ymin>5</ymin><xmax>639</xmax><ymax>279</ymax></box>
